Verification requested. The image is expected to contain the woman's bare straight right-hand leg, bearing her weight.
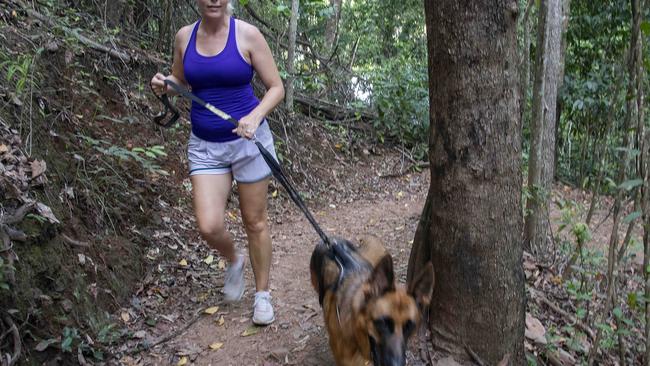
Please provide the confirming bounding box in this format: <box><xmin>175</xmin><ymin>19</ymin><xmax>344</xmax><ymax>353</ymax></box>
<box><xmin>237</xmin><ymin>178</ymin><xmax>272</xmax><ymax>292</ymax></box>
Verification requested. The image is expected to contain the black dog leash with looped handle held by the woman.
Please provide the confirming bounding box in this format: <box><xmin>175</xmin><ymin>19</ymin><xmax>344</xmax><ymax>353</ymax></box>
<box><xmin>154</xmin><ymin>79</ymin><xmax>336</xmax><ymax>248</ymax></box>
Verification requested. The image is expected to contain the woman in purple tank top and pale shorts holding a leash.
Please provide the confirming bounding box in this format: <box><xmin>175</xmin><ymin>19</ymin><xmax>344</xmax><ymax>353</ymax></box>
<box><xmin>151</xmin><ymin>0</ymin><xmax>284</xmax><ymax>325</ymax></box>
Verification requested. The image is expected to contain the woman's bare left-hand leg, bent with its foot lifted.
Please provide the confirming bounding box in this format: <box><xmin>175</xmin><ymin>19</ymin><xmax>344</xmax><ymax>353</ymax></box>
<box><xmin>190</xmin><ymin>173</ymin><xmax>236</xmax><ymax>263</ymax></box>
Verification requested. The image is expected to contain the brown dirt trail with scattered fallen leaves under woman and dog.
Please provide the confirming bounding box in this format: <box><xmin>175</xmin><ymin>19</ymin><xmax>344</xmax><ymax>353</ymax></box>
<box><xmin>115</xmin><ymin>164</ymin><xmax>428</xmax><ymax>365</ymax></box>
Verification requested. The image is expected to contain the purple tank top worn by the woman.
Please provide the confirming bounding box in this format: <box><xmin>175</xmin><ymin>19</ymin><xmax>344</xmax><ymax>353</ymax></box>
<box><xmin>183</xmin><ymin>17</ymin><xmax>260</xmax><ymax>142</ymax></box>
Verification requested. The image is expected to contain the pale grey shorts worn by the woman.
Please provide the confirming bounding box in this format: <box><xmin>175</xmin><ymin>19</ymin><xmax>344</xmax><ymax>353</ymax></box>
<box><xmin>187</xmin><ymin>122</ymin><xmax>277</xmax><ymax>183</ymax></box>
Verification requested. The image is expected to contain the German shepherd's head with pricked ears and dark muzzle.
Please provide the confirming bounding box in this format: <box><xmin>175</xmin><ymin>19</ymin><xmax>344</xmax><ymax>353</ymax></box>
<box><xmin>359</xmin><ymin>254</ymin><xmax>434</xmax><ymax>366</ymax></box>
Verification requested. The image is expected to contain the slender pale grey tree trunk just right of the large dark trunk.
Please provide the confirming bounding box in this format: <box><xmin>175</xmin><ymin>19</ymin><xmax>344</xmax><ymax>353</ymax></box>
<box><xmin>524</xmin><ymin>0</ymin><xmax>562</xmax><ymax>253</ymax></box>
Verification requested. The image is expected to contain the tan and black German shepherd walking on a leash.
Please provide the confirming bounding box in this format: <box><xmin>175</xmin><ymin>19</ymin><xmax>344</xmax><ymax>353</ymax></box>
<box><xmin>310</xmin><ymin>237</ymin><xmax>434</xmax><ymax>366</ymax></box>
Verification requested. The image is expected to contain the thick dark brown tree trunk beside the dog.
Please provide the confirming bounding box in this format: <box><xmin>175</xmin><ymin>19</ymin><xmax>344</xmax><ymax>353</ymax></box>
<box><xmin>408</xmin><ymin>0</ymin><xmax>525</xmax><ymax>365</ymax></box>
